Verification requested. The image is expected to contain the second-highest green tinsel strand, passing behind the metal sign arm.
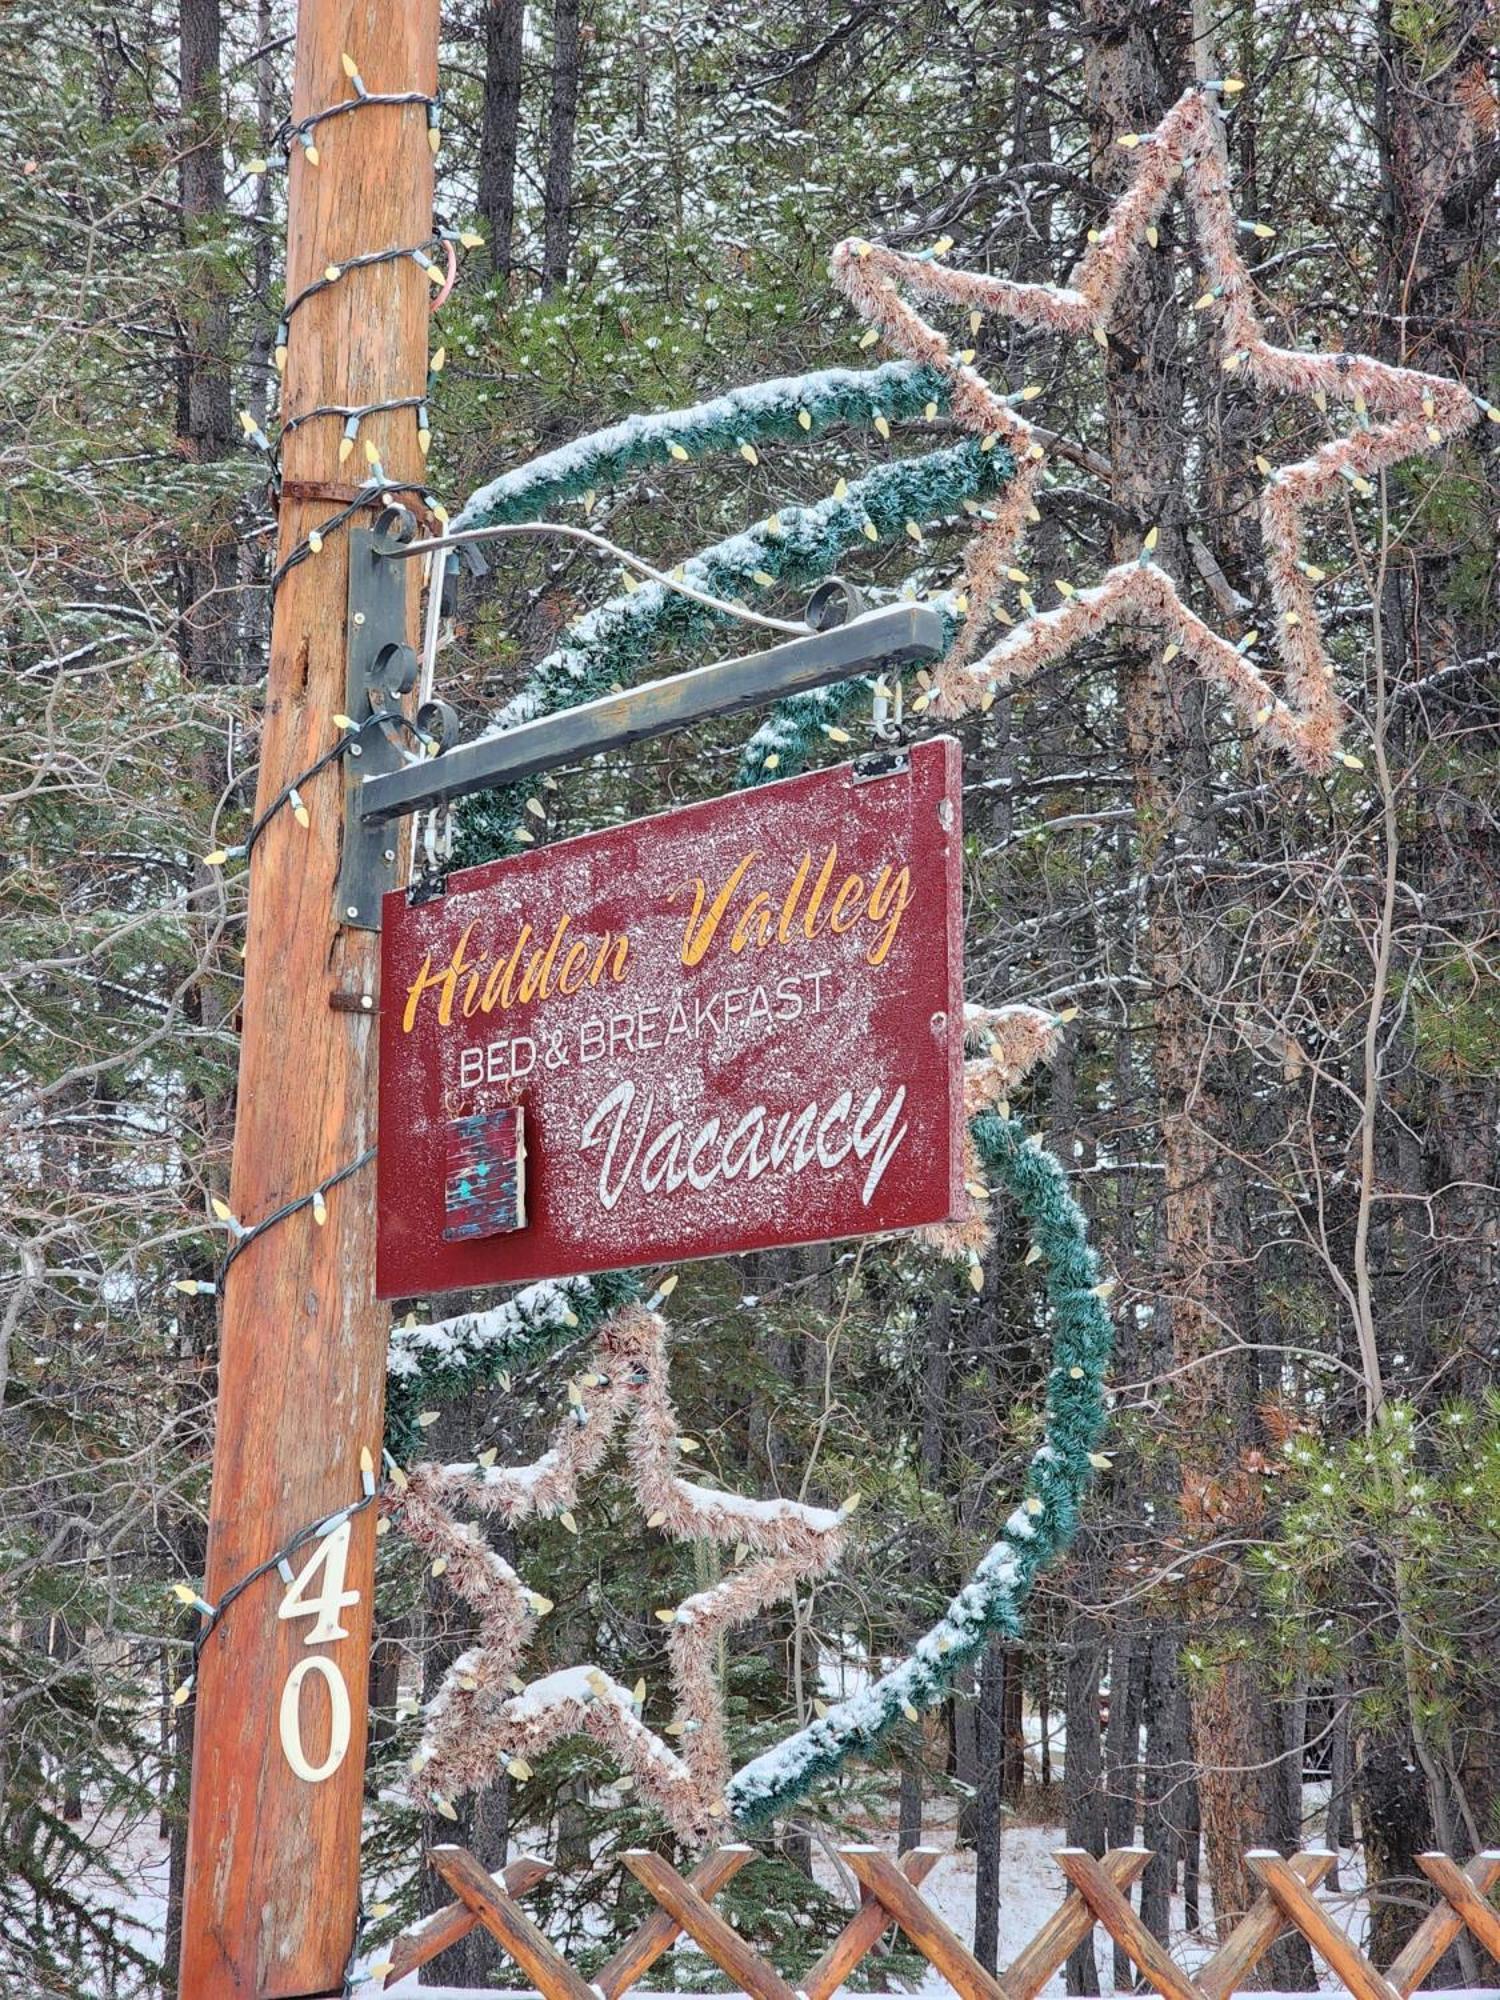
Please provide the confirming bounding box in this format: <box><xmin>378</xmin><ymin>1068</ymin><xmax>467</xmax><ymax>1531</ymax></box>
<box><xmin>454</xmin><ymin>438</ymin><xmax>1014</xmax><ymax>868</ymax></box>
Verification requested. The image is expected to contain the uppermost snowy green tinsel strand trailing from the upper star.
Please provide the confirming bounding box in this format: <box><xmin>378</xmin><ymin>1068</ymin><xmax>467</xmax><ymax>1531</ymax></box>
<box><xmin>452</xmin><ymin>362</ymin><xmax>948</xmax><ymax>530</ymax></box>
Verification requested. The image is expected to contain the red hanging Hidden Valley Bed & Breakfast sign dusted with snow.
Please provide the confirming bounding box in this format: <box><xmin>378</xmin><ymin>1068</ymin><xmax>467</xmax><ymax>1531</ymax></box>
<box><xmin>376</xmin><ymin>738</ymin><xmax>964</xmax><ymax>1298</ymax></box>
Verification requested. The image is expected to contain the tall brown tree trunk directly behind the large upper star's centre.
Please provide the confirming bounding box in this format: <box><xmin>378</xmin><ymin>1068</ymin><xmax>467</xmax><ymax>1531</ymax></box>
<box><xmin>1084</xmin><ymin>0</ymin><xmax>1310</xmax><ymax>1984</ymax></box>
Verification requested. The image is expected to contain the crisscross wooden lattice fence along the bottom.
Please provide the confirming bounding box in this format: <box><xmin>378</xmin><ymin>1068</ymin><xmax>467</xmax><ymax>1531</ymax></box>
<box><xmin>386</xmin><ymin>1846</ymin><xmax>1500</xmax><ymax>2000</ymax></box>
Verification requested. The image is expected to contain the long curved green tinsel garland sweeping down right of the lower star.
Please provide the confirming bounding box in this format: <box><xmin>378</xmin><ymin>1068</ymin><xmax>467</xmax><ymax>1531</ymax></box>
<box><xmin>726</xmin><ymin>1112</ymin><xmax>1114</xmax><ymax>1830</ymax></box>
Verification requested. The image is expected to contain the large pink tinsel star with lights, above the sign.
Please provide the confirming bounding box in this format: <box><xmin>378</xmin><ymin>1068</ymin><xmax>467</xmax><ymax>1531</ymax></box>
<box><xmin>830</xmin><ymin>80</ymin><xmax>1500</xmax><ymax>772</ymax></box>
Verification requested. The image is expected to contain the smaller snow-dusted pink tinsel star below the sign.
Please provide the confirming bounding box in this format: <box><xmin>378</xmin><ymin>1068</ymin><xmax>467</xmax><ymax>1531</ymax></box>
<box><xmin>392</xmin><ymin>1294</ymin><xmax>852</xmax><ymax>1844</ymax></box>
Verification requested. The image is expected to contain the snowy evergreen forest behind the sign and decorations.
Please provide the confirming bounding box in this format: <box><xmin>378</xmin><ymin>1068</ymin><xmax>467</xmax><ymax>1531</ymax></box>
<box><xmin>0</xmin><ymin>0</ymin><xmax>1500</xmax><ymax>1994</ymax></box>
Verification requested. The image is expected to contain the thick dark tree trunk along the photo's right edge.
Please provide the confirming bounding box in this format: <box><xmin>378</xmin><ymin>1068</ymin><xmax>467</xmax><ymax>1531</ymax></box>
<box><xmin>1376</xmin><ymin>0</ymin><xmax>1500</xmax><ymax>1912</ymax></box>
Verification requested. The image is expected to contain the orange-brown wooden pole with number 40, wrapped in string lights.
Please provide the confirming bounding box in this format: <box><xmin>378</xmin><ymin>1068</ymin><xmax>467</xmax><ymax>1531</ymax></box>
<box><xmin>178</xmin><ymin>0</ymin><xmax>438</xmax><ymax>2000</ymax></box>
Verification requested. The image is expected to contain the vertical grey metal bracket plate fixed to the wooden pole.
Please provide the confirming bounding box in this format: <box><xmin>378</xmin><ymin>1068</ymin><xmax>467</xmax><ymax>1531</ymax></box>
<box><xmin>334</xmin><ymin>528</ymin><xmax>416</xmax><ymax>930</ymax></box>
